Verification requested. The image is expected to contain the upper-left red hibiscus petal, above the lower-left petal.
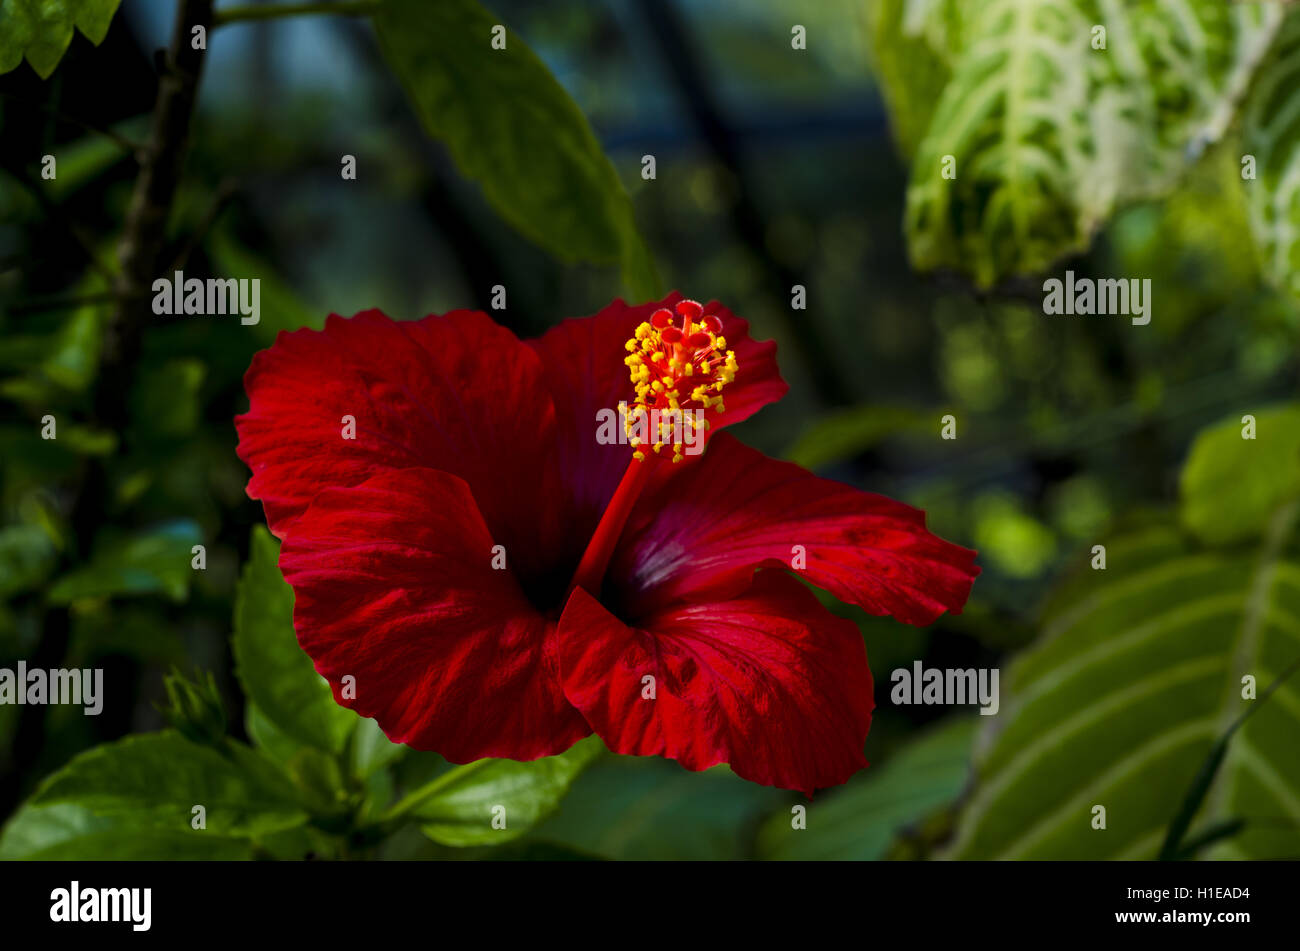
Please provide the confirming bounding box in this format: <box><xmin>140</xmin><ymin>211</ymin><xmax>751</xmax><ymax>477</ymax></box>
<box><xmin>235</xmin><ymin>311</ymin><xmax>559</xmax><ymax>576</ymax></box>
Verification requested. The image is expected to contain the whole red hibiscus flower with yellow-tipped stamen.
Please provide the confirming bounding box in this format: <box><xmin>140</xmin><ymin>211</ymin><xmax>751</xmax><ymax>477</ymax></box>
<box><xmin>235</xmin><ymin>294</ymin><xmax>979</xmax><ymax>793</ymax></box>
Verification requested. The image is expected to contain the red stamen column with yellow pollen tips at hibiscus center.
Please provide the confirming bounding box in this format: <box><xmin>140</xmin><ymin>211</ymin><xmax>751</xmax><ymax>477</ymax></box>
<box><xmin>566</xmin><ymin>300</ymin><xmax>738</xmax><ymax>598</ymax></box>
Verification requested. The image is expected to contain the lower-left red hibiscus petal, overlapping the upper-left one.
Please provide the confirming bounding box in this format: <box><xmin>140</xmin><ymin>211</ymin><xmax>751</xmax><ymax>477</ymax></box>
<box><xmin>280</xmin><ymin>469</ymin><xmax>590</xmax><ymax>763</ymax></box>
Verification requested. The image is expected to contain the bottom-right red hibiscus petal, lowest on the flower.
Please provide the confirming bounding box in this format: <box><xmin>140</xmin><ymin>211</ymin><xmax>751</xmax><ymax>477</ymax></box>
<box><xmin>559</xmin><ymin>572</ymin><xmax>874</xmax><ymax>794</ymax></box>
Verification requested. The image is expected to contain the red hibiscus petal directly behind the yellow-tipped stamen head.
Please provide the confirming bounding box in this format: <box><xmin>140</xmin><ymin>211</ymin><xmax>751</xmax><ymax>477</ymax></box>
<box><xmin>528</xmin><ymin>291</ymin><xmax>789</xmax><ymax>550</ymax></box>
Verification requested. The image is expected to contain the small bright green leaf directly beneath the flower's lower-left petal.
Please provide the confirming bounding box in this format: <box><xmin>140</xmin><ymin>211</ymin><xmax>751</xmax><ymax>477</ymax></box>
<box><xmin>405</xmin><ymin>737</ymin><xmax>605</xmax><ymax>846</ymax></box>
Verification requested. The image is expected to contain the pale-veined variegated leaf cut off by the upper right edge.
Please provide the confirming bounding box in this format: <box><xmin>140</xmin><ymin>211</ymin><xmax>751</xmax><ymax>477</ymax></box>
<box><xmin>1242</xmin><ymin>10</ymin><xmax>1300</xmax><ymax>304</ymax></box>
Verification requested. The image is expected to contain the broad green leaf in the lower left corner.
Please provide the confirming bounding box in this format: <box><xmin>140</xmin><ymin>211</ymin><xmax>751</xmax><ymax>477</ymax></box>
<box><xmin>30</xmin><ymin>730</ymin><xmax>307</xmax><ymax>837</ymax></box>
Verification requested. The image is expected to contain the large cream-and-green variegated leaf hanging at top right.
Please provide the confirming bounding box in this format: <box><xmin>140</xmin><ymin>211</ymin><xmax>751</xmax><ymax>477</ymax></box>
<box><xmin>906</xmin><ymin>0</ymin><xmax>1282</xmax><ymax>287</ymax></box>
